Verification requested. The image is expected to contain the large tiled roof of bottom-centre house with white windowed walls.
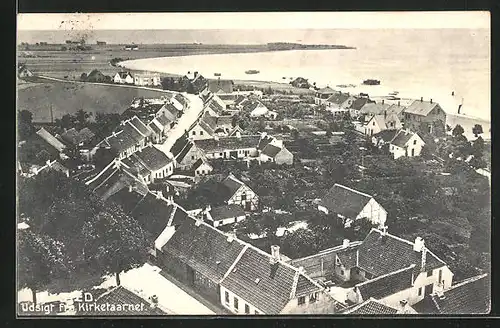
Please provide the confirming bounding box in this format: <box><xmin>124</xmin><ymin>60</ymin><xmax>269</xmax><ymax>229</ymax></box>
<box><xmin>221</xmin><ymin>247</ymin><xmax>321</xmax><ymax>314</ymax></box>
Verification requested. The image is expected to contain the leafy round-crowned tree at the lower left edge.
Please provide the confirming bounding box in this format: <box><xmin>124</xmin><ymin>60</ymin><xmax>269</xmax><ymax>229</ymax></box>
<box><xmin>17</xmin><ymin>228</ymin><xmax>72</xmax><ymax>304</ymax></box>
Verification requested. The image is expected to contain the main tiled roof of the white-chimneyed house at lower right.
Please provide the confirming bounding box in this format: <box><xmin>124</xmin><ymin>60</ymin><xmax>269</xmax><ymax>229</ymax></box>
<box><xmin>358</xmin><ymin>229</ymin><xmax>446</xmax><ymax>276</ymax></box>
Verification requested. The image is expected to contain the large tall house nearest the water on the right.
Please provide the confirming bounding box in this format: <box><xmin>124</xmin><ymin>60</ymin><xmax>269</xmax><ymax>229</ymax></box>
<box><xmin>403</xmin><ymin>97</ymin><xmax>446</xmax><ymax>135</ymax></box>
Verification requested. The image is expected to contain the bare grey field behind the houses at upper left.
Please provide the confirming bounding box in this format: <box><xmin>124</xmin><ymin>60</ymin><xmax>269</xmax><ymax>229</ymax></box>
<box><xmin>17</xmin><ymin>81</ymin><xmax>168</xmax><ymax>122</ymax></box>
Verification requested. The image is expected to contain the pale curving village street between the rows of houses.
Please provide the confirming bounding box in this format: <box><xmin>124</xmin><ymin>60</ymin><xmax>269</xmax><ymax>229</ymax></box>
<box><xmin>156</xmin><ymin>93</ymin><xmax>203</xmax><ymax>153</ymax></box>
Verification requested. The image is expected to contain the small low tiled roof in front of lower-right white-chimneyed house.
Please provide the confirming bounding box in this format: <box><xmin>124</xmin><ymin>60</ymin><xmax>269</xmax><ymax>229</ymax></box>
<box><xmin>356</xmin><ymin>264</ymin><xmax>415</xmax><ymax>300</ymax></box>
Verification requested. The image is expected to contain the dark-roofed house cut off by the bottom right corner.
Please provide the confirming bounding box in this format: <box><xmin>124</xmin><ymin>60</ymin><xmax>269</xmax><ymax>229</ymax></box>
<box><xmin>413</xmin><ymin>273</ymin><xmax>491</xmax><ymax>315</ymax></box>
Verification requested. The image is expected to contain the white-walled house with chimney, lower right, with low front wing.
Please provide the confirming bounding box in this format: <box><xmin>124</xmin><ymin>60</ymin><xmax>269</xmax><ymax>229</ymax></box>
<box><xmin>343</xmin><ymin>229</ymin><xmax>453</xmax><ymax>307</ymax></box>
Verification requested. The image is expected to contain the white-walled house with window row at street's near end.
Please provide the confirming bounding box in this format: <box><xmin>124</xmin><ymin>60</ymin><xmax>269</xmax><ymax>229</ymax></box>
<box><xmin>121</xmin><ymin>145</ymin><xmax>174</xmax><ymax>184</ymax></box>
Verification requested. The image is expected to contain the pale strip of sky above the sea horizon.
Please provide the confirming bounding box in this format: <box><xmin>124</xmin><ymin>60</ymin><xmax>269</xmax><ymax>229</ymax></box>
<box><xmin>17</xmin><ymin>11</ymin><xmax>490</xmax><ymax>30</ymax></box>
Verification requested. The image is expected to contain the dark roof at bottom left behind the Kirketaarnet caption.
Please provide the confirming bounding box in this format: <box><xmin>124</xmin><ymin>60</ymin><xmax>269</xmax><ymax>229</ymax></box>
<box><xmin>91</xmin><ymin>286</ymin><xmax>167</xmax><ymax>316</ymax></box>
